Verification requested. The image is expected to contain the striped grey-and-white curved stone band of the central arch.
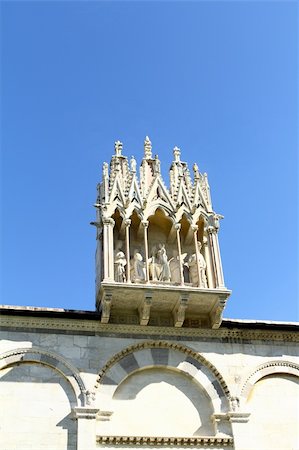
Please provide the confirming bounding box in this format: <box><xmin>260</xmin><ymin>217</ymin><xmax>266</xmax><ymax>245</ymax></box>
<box><xmin>95</xmin><ymin>341</ymin><xmax>231</xmax><ymax>411</ymax></box>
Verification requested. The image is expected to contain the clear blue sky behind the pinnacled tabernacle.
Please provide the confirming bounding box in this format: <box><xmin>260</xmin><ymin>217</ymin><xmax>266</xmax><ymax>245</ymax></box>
<box><xmin>1</xmin><ymin>1</ymin><xmax>298</xmax><ymax>320</ymax></box>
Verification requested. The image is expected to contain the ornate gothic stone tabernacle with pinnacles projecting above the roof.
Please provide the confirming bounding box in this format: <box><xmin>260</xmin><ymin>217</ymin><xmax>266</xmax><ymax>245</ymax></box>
<box><xmin>93</xmin><ymin>137</ymin><xmax>230</xmax><ymax>328</ymax></box>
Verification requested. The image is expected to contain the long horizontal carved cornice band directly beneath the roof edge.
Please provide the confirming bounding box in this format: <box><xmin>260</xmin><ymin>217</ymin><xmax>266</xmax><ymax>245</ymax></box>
<box><xmin>0</xmin><ymin>315</ymin><xmax>299</xmax><ymax>343</ymax></box>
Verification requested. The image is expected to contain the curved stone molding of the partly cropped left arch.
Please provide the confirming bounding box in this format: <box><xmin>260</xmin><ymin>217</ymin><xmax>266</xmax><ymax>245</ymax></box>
<box><xmin>0</xmin><ymin>347</ymin><xmax>88</xmax><ymax>406</ymax></box>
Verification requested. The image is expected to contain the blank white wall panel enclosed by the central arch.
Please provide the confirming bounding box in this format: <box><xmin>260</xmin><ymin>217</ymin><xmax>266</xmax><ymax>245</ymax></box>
<box><xmin>111</xmin><ymin>367</ymin><xmax>215</xmax><ymax>436</ymax></box>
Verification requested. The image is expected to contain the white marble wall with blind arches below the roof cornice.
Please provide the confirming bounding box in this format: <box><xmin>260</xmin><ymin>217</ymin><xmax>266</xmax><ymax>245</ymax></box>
<box><xmin>0</xmin><ymin>324</ymin><xmax>299</xmax><ymax>450</ymax></box>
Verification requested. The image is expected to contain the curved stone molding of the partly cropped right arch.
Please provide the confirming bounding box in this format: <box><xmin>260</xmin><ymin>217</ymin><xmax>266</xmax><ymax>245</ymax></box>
<box><xmin>240</xmin><ymin>360</ymin><xmax>299</xmax><ymax>402</ymax></box>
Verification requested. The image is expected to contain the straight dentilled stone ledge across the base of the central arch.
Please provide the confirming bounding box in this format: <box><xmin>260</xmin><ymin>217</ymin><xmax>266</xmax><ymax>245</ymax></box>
<box><xmin>96</xmin><ymin>436</ymin><xmax>234</xmax><ymax>447</ymax></box>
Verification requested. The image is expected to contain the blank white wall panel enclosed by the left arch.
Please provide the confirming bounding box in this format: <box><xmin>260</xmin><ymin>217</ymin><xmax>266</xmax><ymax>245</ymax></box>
<box><xmin>0</xmin><ymin>363</ymin><xmax>77</xmax><ymax>450</ymax></box>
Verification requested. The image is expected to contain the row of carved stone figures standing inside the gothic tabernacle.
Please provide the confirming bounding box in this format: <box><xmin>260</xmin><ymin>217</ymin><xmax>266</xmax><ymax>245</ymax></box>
<box><xmin>114</xmin><ymin>241</ymin><xmax>208</xmax><ymax>288</ymax></box>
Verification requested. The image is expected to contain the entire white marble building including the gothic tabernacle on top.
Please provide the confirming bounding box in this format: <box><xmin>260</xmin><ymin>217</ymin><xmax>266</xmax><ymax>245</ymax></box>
<box><xmin>0</xmin><ymin>138</ymin><xmax>299</xmax><ymax>450</ymax></box>
